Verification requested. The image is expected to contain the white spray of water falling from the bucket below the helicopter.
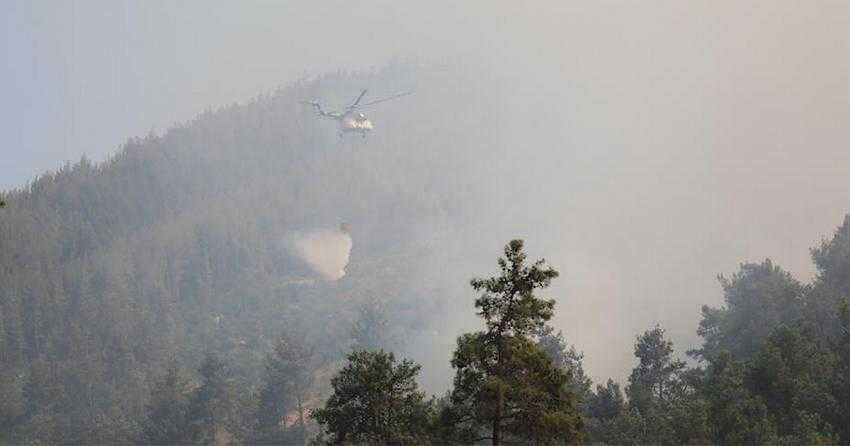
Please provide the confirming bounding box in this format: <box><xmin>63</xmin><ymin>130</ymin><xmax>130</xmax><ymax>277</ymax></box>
<box><xmin>289</xmin><ymin>225</ymin><xmax>353</xmax><ymax>281</ymax></box>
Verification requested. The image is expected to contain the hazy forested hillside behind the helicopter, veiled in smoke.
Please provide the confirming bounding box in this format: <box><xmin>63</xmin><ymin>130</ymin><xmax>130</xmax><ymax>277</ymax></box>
<box><xmin>0</xmin><ymin>63</ymin><xmax>504</xmax><ymax>443</ymax></box>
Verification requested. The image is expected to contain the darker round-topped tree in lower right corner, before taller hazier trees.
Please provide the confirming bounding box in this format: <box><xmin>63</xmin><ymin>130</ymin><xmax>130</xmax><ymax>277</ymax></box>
<box><xmin>688</xmin><ymin>326</ymin><xmax>842</xmax><ymax>444</ymax></box>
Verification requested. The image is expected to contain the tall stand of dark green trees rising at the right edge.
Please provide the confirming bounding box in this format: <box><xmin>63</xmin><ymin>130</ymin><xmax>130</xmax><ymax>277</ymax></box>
<box><xmin>684</xmin><ymin>218</ymin><xmax>850</xmax><ymax>444</ymax></box>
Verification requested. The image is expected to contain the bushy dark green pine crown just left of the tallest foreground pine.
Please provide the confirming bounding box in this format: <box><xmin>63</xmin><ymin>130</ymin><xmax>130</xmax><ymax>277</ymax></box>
<box><xmin>313</xmin><ymin>350</ymin><xmax>433</xmax><ymax>445</ymax></box>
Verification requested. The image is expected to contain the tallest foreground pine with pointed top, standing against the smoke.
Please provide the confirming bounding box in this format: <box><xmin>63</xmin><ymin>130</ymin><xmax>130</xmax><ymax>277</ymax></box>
<box><xmin>445</xmin><ymin>240</ymin><xmax>582</xmax><ymax>446</ymax></box>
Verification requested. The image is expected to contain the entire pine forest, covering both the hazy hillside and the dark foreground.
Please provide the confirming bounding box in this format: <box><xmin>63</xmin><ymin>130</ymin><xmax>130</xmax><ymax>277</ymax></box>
<box><xmin>0</xmin><ymin>63</ymin><xmax>850</xmax><ymax>445</ymax></box>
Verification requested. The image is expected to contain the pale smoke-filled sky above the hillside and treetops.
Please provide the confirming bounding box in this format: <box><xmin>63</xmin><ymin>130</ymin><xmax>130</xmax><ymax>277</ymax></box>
<box><xmin>0</xmin><ymin>0</ymin><xmax>850</xmax><ymax>379</ymax></box>
